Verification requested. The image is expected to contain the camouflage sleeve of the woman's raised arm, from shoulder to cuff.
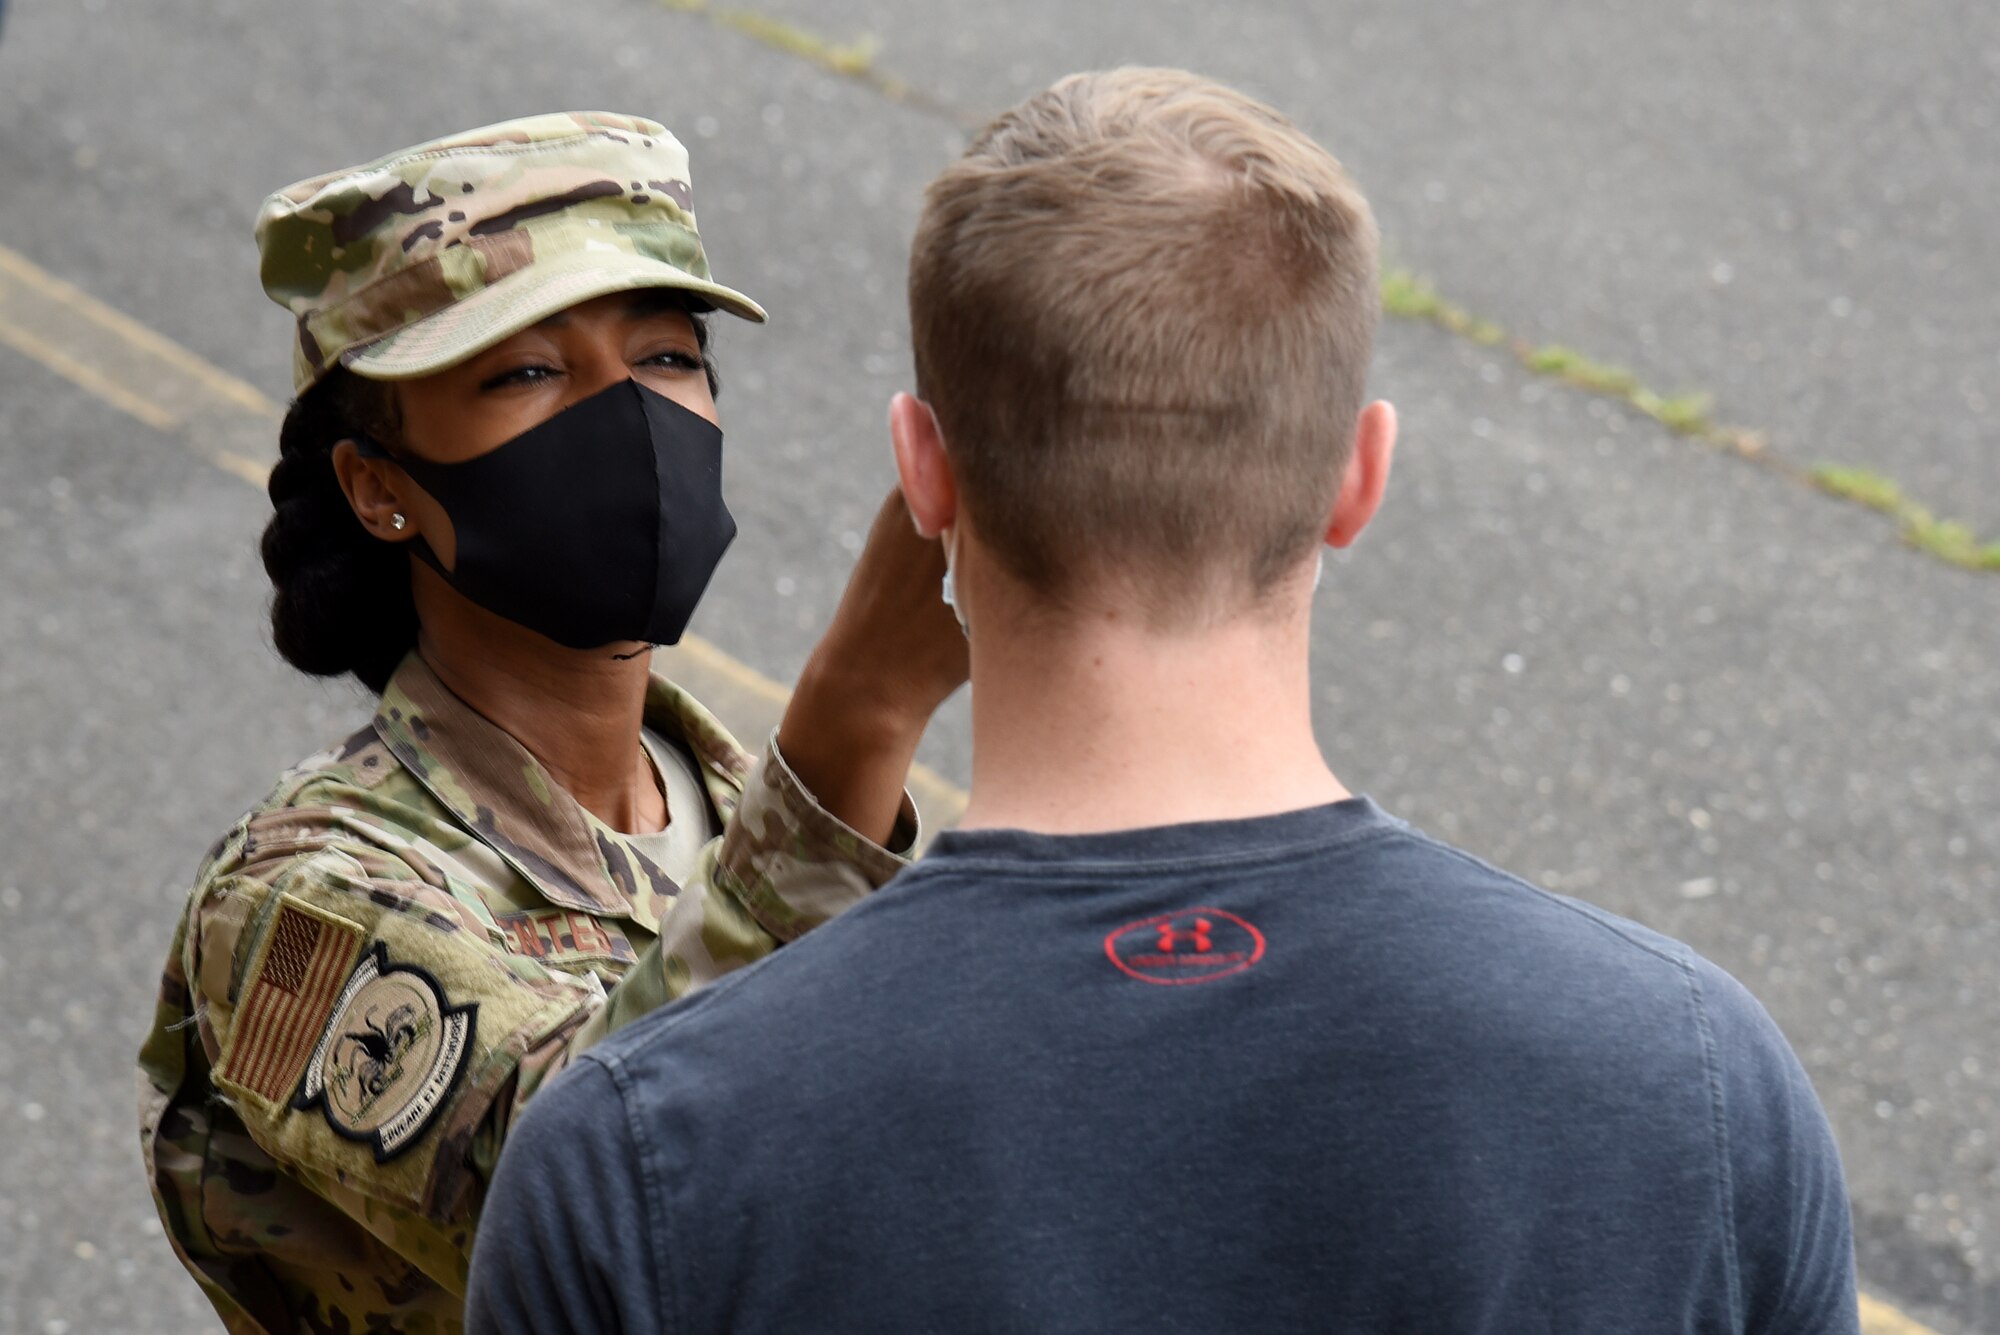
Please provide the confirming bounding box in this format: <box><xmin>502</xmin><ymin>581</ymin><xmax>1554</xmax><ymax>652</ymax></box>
<box><xmin>146</xmin><ymin>723</ymin><xmax>916</xmax><ymax>1293</ymax></box>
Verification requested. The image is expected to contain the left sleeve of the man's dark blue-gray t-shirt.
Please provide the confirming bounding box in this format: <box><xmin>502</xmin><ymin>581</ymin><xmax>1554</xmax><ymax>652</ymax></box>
<box><xmin>466</xmin><ymin>1061</ymin><xmax>648</xmax><ymax>1335</ymax></box>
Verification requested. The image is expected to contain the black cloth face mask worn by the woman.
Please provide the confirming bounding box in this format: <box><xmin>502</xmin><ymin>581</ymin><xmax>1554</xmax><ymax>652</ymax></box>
<box><xmin>358</xmin><ymin>380</ymin><xmax>736</xmax><ymax>650</ymax></box>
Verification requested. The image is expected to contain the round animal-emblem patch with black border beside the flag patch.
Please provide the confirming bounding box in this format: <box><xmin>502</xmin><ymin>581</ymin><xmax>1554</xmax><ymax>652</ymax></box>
<box><xmin>292</xmin><ymin>941</ymin><xmax>478</xmax><ymax>1163</ymax></box>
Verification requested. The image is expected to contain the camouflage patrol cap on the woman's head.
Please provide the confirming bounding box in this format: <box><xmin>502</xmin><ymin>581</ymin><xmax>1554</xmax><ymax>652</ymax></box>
<box><xmin>256</xmin><ymin>112</ymin><xmax>764</xmax><ymax>392</ymax></box>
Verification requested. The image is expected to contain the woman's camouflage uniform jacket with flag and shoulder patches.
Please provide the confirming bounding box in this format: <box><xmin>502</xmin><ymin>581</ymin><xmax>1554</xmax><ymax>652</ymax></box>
<box><xmin>140</xmin><ymin>654</ymin><xmax>914</xmax><ymax>1335</ymax></box>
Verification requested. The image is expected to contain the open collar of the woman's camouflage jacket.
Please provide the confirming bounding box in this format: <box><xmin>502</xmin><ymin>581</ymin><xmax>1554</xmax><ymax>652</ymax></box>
<box><xmin>374</xmin><ymin>652</ymin><xmax>750</xmax><ymax>929</ymax></box>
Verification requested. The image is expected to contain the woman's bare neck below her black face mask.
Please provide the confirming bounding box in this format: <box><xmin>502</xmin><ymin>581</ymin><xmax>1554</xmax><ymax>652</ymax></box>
<box><xmin>418</xmin><ymin>579</ymin><xmax>668</xmax><ymax>833</ymax></box>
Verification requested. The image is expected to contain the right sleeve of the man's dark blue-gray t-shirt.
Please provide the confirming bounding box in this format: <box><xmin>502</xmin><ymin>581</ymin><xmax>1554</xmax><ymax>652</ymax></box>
<box><xmin>1702</xmin><ymin>961</ymin><xmax>1860</xmax><ymax>1335</ymax></box>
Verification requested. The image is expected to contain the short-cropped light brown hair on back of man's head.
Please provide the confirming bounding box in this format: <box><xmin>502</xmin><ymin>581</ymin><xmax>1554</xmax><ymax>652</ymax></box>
<box><xmin>910</xmin><ymin>70</ymin><xmax>1380</xmax><ymax>628</ymax></box>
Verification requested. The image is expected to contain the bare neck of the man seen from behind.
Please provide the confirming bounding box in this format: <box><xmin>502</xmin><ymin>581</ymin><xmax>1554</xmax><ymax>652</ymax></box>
<box><xmin>960</xmin><ymin>610</ymin><xmax>1350</xmax><ymax>833</ymax></box>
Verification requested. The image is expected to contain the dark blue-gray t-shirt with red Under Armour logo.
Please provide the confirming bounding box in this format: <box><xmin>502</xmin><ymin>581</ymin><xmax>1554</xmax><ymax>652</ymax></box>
<box><xmin>468</xmin><ymin>799</ymin><xmax>1858</xmax><ymax>1335</ymax></box>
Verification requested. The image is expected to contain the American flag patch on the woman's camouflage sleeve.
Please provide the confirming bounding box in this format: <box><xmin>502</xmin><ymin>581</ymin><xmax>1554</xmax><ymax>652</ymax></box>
<box><xmin>216</xmin><ymin>895</ymin><xmax>362</xmax><ymax>1105</ymax></box>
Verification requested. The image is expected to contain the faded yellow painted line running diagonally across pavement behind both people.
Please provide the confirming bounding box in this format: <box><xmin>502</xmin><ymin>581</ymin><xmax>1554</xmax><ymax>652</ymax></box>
<box><xmin>0</xmin><ymin>246</ymin><xmax>1968</xmax><ymax>1335</ymax></box>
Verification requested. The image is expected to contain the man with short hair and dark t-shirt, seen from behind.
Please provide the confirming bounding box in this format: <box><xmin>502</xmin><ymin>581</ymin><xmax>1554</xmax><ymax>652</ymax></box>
<box><xmin>470</xmin><ymin>70</ymin><xmax>1858</xmax><ymax>1335</ymax></box>
